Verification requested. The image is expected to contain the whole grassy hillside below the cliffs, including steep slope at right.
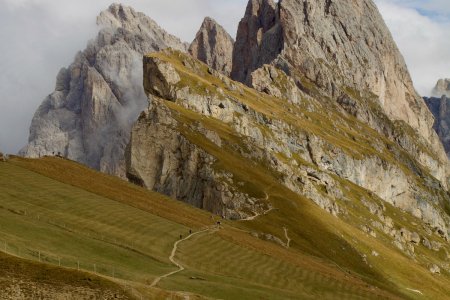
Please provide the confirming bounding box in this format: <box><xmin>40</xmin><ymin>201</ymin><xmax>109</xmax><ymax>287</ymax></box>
<box><xmin>0</xmin><ymin>158</ymin><xmax>450</xmax><ymax>299</ymax></box>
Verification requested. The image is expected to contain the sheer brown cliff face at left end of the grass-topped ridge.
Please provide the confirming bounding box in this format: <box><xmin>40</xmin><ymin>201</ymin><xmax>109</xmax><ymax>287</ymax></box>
<box><xmin>126</xmin><ymin>52</ymin><xmax>268</xmax><ymax>219</ymax></box>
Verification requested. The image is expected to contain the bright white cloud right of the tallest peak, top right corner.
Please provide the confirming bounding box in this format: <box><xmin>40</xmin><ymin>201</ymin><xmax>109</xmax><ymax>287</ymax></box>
<box><xmin>376</xmin><ymin>0</ymin><xmax>450</xmax><ymax>96</ymax></box>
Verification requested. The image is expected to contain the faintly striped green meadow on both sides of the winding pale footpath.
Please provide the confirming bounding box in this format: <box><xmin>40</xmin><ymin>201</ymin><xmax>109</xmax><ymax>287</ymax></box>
<box><xmin>0</xmin><ymin>158</ymin><xmax>414</xmax><ymax>299</ymax></box>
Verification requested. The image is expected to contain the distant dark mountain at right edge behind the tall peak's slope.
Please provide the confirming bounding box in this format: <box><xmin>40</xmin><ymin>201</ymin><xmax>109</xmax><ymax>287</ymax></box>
<box><xmin>424</xmin><ymin>79</ymin><xmax>450</xmax><ymax>157</ymax></box>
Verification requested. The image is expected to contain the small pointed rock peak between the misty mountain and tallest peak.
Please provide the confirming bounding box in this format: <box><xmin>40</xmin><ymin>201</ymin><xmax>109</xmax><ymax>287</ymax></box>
<box><xmin>189</xmin><ymin>17</ymin><xmax>234</xmax><ymax>76</ymax></box>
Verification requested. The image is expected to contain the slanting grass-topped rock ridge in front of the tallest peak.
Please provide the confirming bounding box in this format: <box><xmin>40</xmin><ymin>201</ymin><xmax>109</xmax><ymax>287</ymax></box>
<box><xmin>127</xmin><ymin>51</ymin><xmax>449</xmax><ymax>238</ymax></box>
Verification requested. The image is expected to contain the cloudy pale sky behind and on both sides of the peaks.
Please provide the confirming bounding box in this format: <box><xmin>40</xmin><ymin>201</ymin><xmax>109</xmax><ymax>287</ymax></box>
<box><xmin>0</xmin><ymin>0</ymin><xmax>450</xmax><ymax>153</ymax></box>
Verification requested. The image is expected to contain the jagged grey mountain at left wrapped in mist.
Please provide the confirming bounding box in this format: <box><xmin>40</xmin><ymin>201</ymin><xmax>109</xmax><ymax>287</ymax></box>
<box><xmin>21</xmin><ymin>4</ymin><xmax>186</xmax><ymax>177</ymax></box>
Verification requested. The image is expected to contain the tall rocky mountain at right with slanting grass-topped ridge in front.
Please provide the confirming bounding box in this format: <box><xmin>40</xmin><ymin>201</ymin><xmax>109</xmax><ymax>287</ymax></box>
<box><xmin>127</xmin><ymin>0</ymin><xmax>449</xmax><ymax>232</ymax></box>
